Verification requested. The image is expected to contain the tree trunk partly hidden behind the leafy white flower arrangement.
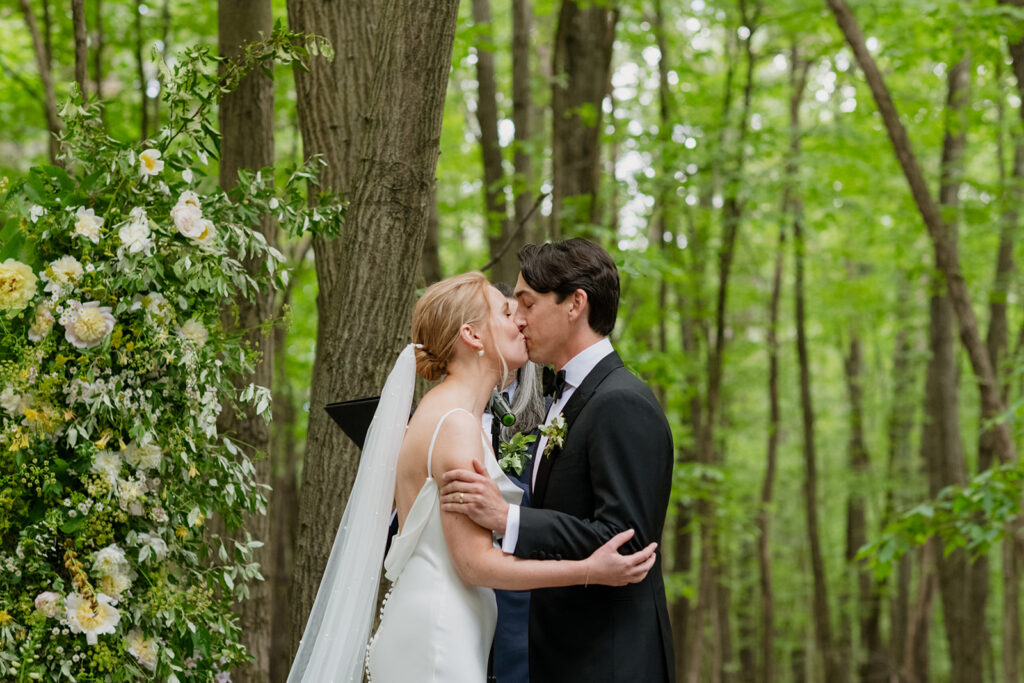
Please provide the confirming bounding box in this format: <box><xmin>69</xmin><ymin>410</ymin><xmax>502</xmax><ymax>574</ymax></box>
<box><xmin>217</xmin><ymin>0</ymin><xmax>276</xmax><ymax>683</ymax></box>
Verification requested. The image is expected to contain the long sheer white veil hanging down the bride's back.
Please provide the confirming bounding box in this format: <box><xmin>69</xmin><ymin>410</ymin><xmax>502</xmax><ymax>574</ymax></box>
<box><xmin>288</xmin><ymin>344</ymin><xmax>416</xmax><ymax>683</ymax></box>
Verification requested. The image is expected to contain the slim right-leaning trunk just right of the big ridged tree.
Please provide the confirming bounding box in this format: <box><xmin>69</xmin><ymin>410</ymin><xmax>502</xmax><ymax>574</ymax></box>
<box><xmin>472</xmin><ymin>0</ymin><xmax>519</xmax><ymax>285</ymax></box>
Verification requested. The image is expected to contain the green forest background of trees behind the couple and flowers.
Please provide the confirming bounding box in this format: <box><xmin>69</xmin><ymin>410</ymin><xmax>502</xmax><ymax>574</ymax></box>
<box><xmin>0</xmin><ymin>0</ymin><xmax>1024</xmax><ymax>683</ymax></box>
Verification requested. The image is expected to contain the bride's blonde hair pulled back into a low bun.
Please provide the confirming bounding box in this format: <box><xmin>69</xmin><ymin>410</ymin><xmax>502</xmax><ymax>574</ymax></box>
<box><xmin>412</xmin><ymin>270</ymin><xmax>490</xmax><ymax>380</ymax></box>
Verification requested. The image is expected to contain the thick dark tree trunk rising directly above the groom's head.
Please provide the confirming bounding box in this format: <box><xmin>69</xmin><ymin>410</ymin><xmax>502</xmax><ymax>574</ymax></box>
<box><xmin>551</xmin><ymin>0</ymin><xmax>618</xmax><ymax>240</ymax></box>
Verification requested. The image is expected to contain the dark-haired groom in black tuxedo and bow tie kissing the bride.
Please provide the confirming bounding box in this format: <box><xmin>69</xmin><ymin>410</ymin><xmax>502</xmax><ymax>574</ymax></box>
<box><xmin>441</xmin><ymin>239</ymin><xmax>673</xmax><ymax>683</ymax></box>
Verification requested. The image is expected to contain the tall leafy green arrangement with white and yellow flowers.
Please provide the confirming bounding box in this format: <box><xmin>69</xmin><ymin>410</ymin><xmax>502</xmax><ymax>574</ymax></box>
<box><xmin>0</xmin><ymin>27</ymin><xmax>343</xmax><ymax>681</ymax></box>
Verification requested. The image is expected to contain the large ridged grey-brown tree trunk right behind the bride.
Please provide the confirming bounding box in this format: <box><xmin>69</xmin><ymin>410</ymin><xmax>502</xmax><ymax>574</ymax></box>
<box><xmin>288</xmin><ymin>0</ymin><xmax>458</xmax><ymax>663</ymax></box>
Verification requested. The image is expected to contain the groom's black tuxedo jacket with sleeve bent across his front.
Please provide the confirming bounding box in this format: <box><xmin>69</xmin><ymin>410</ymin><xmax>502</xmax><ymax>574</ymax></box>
<box><xmin>515</xmin><ymin>353</ymin><xmax>674</xmax><ymax>683</ymax></box>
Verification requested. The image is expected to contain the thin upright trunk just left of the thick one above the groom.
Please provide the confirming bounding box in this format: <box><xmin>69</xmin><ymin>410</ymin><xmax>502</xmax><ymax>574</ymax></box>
<box><xmin>509</xmin><ymin>0</ymin><xmax>542</xmax><ymax>246</ymax></box>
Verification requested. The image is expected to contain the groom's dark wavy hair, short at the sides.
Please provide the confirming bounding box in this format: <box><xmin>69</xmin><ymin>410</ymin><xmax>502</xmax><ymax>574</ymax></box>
<box><xmin>519</xmin><ymin>238</ymin><xmax>618</xmax><ymax>335</ymax></box>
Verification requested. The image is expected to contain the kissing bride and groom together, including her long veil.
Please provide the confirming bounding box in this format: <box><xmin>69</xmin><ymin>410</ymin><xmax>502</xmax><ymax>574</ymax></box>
<box><xmin>289</xmin><ymin>239</ymin><xmax>673</xmax><ymax>683</ymax></box>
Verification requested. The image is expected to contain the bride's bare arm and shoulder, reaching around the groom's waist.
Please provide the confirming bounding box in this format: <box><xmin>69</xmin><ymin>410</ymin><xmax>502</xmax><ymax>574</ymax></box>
<box><xmin>431</xmin><ymin>413</ymin><xmax>657</xmax><ymax>590</ymax></box>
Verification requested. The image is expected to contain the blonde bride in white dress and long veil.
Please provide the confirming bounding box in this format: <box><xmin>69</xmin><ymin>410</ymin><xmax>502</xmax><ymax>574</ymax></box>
<box><xmin>288</xmin><ymin>272</ymin><xmax>656</xmax><ymax>683</ymax></box>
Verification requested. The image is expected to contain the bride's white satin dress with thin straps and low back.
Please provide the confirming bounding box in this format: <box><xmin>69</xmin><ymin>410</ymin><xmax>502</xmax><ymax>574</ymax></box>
<box><xmin>367</xmin><ymin>409</ymin><xmax>522</xmax><ymax>683</ymax></box>
